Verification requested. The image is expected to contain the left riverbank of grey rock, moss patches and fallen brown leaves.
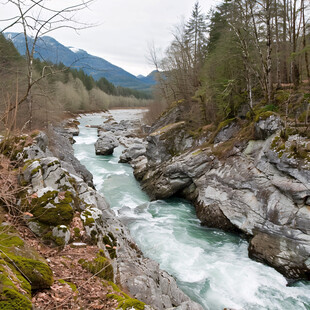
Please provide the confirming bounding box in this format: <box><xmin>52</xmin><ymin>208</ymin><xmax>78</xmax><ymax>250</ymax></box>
<box><xmin>1</xmin><ymin>115</ymin><xmax>201</xmax><ymax>309</ymax></box>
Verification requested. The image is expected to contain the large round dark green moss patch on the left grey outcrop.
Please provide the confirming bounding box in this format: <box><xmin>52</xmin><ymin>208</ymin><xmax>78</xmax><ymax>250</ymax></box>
<box><xmin>30</xmin><ymin>191</ymin><xmax>73</xmax><ymax>226</ymax></box>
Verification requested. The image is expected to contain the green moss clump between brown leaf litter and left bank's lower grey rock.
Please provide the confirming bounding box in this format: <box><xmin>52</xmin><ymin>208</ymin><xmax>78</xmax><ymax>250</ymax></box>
<box><xmin>79</xmin><ymin>251</ymin><xmax>114</xmax><ymax>281</ymax></box>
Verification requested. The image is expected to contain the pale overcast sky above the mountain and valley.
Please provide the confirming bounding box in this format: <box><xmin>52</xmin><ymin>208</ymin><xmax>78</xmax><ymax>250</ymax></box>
<box><xmin>0</xmin><ymin>0</ymin><xmax>219</xmax><ymax>75</ymax></box>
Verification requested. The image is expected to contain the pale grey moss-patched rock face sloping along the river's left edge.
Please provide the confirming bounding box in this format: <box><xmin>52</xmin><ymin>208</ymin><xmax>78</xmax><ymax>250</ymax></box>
<box><xmin>20</xmin><ymin>125</ymin><xmax>202</xmax><ymax>310</ymax></box>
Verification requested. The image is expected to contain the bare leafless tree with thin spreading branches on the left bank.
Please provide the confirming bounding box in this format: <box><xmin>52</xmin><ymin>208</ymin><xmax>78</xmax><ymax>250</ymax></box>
<box><xmin>0</xmin><ymin>0</ymin><xmax>94</xmax><ymax>129</ymax></box>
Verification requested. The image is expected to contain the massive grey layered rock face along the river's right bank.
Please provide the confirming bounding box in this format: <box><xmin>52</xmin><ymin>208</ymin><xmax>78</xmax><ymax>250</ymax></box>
<box><xmin>127</xmin><ymin>115</ymin><xmax>310</xmax><ymax>279</ymax></box>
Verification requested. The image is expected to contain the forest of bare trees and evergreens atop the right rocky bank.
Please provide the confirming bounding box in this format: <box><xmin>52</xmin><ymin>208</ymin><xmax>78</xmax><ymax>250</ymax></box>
<box><xmin>150</xmin><ymin>0</ymin><xmax>310</xmax><ymax>130</ymax></box>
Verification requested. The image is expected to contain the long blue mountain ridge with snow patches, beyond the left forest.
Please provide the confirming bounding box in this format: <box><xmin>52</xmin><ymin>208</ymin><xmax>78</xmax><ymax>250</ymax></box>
<box><xmin>4</xmin><ymin>32</ymin><xmax>155</xmax><ymax>91</ymax></box>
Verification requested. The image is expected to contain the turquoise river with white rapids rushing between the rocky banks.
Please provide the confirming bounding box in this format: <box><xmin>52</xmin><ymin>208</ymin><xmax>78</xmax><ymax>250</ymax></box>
<box><xmin>74</xmin><ymin>110</ymin><xmax>310</xmax><ymax>310</ymax></box>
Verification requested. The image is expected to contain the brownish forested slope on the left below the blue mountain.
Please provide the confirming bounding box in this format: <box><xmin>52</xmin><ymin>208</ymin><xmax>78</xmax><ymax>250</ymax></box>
<box><xmin>0</xmin><ymin>34</ymin><xmax>151</xmax><ymax>131</ymax></box>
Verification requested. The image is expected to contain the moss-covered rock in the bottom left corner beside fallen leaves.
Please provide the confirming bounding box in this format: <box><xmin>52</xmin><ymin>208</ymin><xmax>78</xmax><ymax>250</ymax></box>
<box><xmin>0</xmin><ymin>223</ymin><xmax>53</xmax><ymax>310</ymax></box>
